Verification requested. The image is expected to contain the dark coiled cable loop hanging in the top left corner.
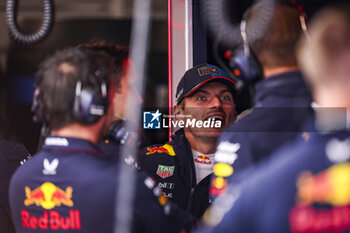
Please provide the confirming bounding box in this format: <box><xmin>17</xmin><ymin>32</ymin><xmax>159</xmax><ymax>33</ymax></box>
<box><xmin>6</xmin><ymin>0</ymin><xmax>54</xmax><ymax>45</ymax></box>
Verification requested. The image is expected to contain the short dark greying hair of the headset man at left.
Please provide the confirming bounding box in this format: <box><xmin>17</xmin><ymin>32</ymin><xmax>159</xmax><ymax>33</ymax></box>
<box><xmin>37</xmin><ymin>48</ymin><xmax>112</xmax><ymax>129</ymax></box>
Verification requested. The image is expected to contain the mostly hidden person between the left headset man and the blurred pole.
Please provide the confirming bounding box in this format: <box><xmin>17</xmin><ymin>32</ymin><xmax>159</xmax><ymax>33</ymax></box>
<box><xmin>77</xmin><ymin>40</ymin><xmax>143</xmax><ymax>153</ymax></box>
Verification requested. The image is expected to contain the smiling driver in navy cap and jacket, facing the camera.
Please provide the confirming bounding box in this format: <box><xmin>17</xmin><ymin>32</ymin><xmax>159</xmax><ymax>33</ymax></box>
<box><xmin>139</xmin><ymin>64</ymin><xmax>237</xmax><ymax>218</ymax></box>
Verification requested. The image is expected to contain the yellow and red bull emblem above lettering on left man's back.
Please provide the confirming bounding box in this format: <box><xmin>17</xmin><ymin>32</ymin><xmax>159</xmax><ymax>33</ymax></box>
<box><xmin>24</xmin><ymin>182</ymin><xmax>73</xmax><ymax>210</ymax></box>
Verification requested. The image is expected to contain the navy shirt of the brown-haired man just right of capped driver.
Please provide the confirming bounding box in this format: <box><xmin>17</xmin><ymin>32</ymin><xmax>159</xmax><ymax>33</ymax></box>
<box><xmin>210</xmin><ymin>71</ymin><xmax>313</xmax><ymax>197</ymax></box>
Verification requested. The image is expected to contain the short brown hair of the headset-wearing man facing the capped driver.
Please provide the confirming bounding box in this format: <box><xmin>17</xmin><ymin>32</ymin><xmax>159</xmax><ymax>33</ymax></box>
<box><xmin>245</xmin><ymin>2</ymin><xmax>302</xmax><ymax>68</ymax></box>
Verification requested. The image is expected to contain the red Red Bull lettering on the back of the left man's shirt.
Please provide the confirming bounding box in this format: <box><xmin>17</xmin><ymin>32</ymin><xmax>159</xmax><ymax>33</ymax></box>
<box><xmin>21</xmin><ymin>209</ymin><xmax>81</xmax><ymax>230</ymax></box>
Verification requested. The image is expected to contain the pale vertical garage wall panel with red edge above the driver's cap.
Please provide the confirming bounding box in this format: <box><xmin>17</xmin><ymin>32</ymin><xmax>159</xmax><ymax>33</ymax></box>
<box><xmin>168</xmin><ymin>0</ymin><xmax>207</xmax><ymax>106</ymax></box>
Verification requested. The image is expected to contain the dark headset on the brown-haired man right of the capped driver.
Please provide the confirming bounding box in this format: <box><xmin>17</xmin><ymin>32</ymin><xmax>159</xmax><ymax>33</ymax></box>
<box><xmin>226</xmin><ymin>0</ymin><xmax>310</xmax><ymax>85</ymax></box>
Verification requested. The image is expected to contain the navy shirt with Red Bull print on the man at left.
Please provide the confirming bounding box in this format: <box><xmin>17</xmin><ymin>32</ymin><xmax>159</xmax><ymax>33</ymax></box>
<box><xmin>9</xmin><ymin>136</ymin><xmax>179</xmax><ymax>233</ymax></box>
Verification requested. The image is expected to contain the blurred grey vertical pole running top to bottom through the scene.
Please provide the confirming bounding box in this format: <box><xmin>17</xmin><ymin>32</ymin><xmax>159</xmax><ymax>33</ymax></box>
<box><xmin>114</xmin><ymin>0</ymin><xmax>151</xmax><ymax>233</ymax></box>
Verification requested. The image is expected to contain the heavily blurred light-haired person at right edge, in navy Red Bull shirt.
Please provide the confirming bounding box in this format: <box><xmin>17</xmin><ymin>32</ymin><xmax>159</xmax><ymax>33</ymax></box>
<box><xmin>201</xmin><ymin>5</ymin><xmax>350</xmax><ymax>233</ymax></box>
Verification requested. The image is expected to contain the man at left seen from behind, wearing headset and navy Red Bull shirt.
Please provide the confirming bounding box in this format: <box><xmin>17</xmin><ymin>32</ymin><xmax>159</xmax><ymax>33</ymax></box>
<box><xmin>10</xmin><ymin>48</ymin><xmax>180</xmax><ymax>233</ymax></box>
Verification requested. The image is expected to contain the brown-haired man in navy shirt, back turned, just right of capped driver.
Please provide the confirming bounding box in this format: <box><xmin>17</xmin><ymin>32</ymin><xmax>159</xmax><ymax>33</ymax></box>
<box><xmin>211</xmin><ymin>3</ymin><xmax>312</xmax><ymax>196</ymax></box>
